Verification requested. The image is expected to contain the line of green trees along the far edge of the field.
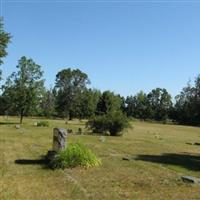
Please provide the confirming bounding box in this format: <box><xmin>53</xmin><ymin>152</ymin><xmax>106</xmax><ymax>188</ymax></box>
<box><xmin>0</xmin><ymin>57</ymin><xmax>200</xmax><ymax>125</ymax></box>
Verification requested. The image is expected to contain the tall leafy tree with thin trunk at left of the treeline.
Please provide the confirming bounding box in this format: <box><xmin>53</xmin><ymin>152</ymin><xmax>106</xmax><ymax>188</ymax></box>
<box><xmin>2</xmin><ymin>56</ymin><xmax>44</xmax><ymax>123</ymax></box>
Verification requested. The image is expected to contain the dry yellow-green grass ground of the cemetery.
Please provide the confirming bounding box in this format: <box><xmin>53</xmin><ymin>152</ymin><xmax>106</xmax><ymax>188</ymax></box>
<box><xmin>0</xmin><ymin>117</ymin><xmax>200</xmax><ymax>200</ymax></box>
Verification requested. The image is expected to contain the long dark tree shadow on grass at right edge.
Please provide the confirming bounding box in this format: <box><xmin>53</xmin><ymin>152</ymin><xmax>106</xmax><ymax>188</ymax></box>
<box><xmin>135</xmin><ymin>154</ymin><xmax>200</xmax><ymax>171</ymax></box>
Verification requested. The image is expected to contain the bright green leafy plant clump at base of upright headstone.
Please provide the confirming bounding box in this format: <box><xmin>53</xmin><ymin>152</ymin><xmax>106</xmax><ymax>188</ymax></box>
<box><xmin>49</xmin><ymin>143</ymin><xmax>101</xmax><ymax>169</ymax></box>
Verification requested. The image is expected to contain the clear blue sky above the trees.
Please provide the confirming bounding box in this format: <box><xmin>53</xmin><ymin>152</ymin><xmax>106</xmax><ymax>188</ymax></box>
<box><xmin>0</xmin><ymin>0</ymin><xmax>200</xmax><ymax>96</ymax></box>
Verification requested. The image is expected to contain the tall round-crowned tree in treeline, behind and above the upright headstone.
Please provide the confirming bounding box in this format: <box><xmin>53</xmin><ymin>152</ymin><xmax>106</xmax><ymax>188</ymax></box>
<box><xmin>55</xmin><ymin>68</ymin><xmax>90</xmax><ymax>119</ymax></box>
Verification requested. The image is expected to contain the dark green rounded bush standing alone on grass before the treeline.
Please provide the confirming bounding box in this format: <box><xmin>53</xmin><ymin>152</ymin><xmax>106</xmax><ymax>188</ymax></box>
<box><xmin>87</xmin><ymin>111</ymin><xmax>129</xmax><ymax>136</ymax></box>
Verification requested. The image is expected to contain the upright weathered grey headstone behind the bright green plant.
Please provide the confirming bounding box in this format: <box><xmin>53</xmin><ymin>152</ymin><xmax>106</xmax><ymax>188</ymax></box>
<box><xmin>53</xmin><ymin>128</ymin><xmax>67</xmax><ymax>151</ymax></box>
